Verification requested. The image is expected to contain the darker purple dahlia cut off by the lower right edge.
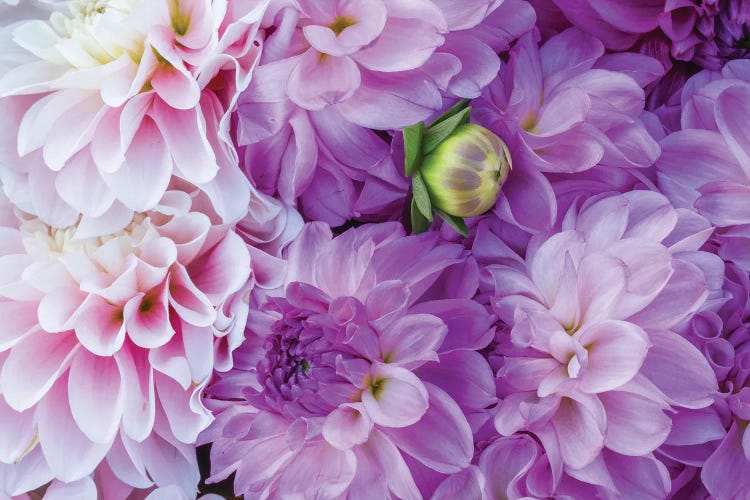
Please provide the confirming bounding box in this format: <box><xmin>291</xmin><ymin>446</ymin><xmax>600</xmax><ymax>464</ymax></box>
<box><xmin>659</xmin><ymin>263</ymin><xmax>750</xmax><ymax>498</ymax></box>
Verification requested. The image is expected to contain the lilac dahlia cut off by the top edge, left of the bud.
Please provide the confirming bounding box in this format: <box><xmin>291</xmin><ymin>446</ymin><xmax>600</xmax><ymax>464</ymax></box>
<box><xmin>237</xmin><ymin>0</ymin><xmax>534</xmax><ymax>226</ymax></box>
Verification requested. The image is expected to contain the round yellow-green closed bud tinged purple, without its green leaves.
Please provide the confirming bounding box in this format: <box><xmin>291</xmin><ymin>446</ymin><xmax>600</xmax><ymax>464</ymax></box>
<box><xmin>420</xmin><ymin>123</ymin><xmax>511</xmax><ymax>217</ymax></box>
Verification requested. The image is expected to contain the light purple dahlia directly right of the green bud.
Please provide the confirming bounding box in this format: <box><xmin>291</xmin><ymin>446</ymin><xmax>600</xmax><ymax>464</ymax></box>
<box><xmin>473</xmin><ymin>28</ymin><xmax>663</xmax><ymax>231</ymax></box>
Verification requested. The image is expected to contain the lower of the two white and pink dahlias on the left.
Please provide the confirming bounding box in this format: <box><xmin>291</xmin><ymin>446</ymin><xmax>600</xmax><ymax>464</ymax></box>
<box><xmin>0</xmin><ymin>191</ymin><xmax>254</xmax><ymax>496</ymax></box>
